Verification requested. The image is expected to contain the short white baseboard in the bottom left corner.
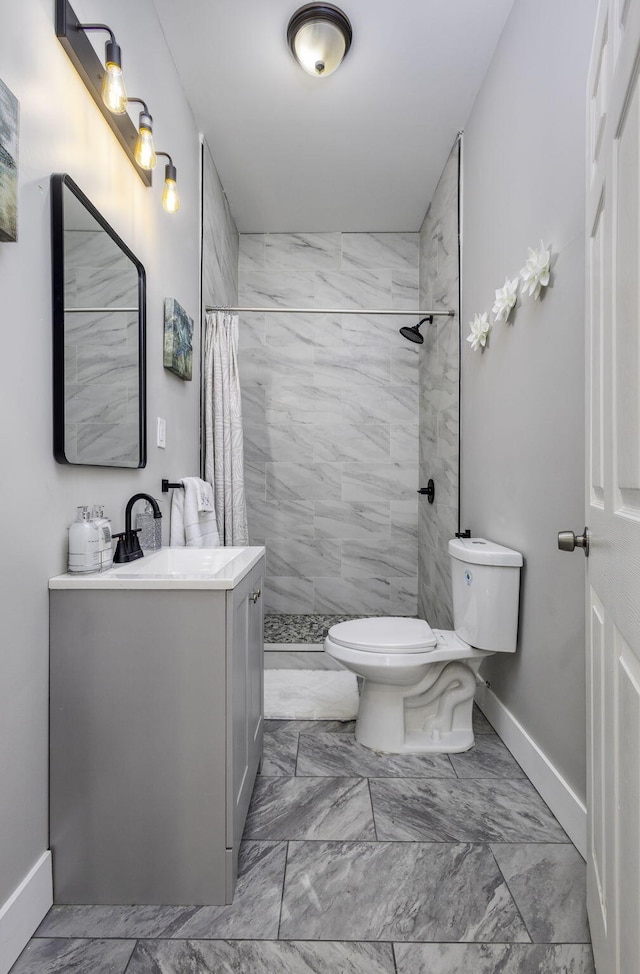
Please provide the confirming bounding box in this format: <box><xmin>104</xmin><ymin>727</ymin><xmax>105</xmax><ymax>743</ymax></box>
<box><xmin>0</xmin><ymin>852</ymin><xmax>53</xmax><ymax>974</ymax></box>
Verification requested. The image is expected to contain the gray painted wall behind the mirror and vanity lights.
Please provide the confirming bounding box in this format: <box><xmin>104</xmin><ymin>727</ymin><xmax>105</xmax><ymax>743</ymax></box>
<box><xmin>0</xmin><ymin>0</ymin><xmax>230</xmax><ymax>932</ymax></box>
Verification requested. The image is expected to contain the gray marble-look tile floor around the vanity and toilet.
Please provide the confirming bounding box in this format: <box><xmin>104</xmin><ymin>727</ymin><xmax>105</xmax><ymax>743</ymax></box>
<box><xmin>12</xmin><ymin>710</ymin><xmax>595</xmax><ymax>974</ymax></box>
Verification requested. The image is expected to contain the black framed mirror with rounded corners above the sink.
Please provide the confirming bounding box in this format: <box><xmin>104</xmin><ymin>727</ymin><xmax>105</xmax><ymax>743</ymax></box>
<box><xmin>51</xmin><ymin>173</ymin><xmax>147</xmax><ymax>467</ymax></box>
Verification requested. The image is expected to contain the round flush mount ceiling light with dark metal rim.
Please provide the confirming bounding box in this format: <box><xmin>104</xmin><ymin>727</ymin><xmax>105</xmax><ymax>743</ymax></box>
<box><xmin>287</xmin><ymin>3</ymin><xmax>352</xmax><ymax>78</ymax></box>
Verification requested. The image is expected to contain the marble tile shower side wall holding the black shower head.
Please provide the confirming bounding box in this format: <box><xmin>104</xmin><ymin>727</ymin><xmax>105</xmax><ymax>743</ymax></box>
<box><xmin>418</xmin><ymin>144</ymin><xmax>460</xmax><ymax>629</ymax></box>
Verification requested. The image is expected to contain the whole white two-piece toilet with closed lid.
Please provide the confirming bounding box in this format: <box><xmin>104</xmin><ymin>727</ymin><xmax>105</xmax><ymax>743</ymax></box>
<box><xmin>324</xmin><ymin>538</ymin><xmax>522</xmax><ymax>754</ymax></box>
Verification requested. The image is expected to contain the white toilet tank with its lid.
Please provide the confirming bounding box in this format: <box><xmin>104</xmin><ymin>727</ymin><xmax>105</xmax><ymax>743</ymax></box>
<box><xmin>449</xmin><ymin>538</ymin><xmax>522</xmax><ymax>653</ymax></box>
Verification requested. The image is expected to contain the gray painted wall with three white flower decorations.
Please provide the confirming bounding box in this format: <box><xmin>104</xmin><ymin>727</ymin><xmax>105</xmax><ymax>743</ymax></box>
<box><xmin>461</xmin><ymin>0</ymin><xmax>595</xmax><ymax>796</ymax></box>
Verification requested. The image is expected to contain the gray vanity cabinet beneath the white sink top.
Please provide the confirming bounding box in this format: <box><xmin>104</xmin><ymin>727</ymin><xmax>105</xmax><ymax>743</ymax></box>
<box><xmin>50</xmin><ymin>558</ymin><xmax>264</xmax><ymax>905</ymax></box>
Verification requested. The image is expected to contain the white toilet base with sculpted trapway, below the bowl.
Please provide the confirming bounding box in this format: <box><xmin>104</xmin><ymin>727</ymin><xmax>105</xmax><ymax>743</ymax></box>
<box><xmin>356</xmin><ymin>654</ymin><xmax>488</xmax><ymax>754</ymax></box>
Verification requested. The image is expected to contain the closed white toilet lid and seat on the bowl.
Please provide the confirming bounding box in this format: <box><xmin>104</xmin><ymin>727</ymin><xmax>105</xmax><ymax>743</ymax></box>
<box><xmin>329</xmin><ymin>616</ymin><xmax>436</xmax><ymax>653</ymax></box>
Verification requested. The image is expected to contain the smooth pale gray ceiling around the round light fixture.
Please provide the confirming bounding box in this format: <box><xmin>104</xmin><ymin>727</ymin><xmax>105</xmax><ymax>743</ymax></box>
<box><xmin>154</xmin><ymin>0</ymin><xmax>513</xmax><ymax>233</ymax></box>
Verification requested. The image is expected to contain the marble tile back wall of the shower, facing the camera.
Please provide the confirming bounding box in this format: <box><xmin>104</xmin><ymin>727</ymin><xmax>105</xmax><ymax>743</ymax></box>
<box><xmin>239</xmin><ymin>232</ymin><xmax>419</xmax><ymax>615</ymax></box>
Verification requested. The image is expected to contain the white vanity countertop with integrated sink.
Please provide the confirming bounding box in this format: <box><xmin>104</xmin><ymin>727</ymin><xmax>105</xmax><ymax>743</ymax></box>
<box><xmin>49</xmin><ymin>547</ymin><xmax>264</xmax><ymax>590</ymax></box>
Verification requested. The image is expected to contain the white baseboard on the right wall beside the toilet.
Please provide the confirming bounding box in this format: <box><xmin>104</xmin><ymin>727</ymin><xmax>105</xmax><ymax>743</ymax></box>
<box><xmin>476</xmin><ymin>684</ymin><xmax>587</xmax><ymax>858</ymax></box>
